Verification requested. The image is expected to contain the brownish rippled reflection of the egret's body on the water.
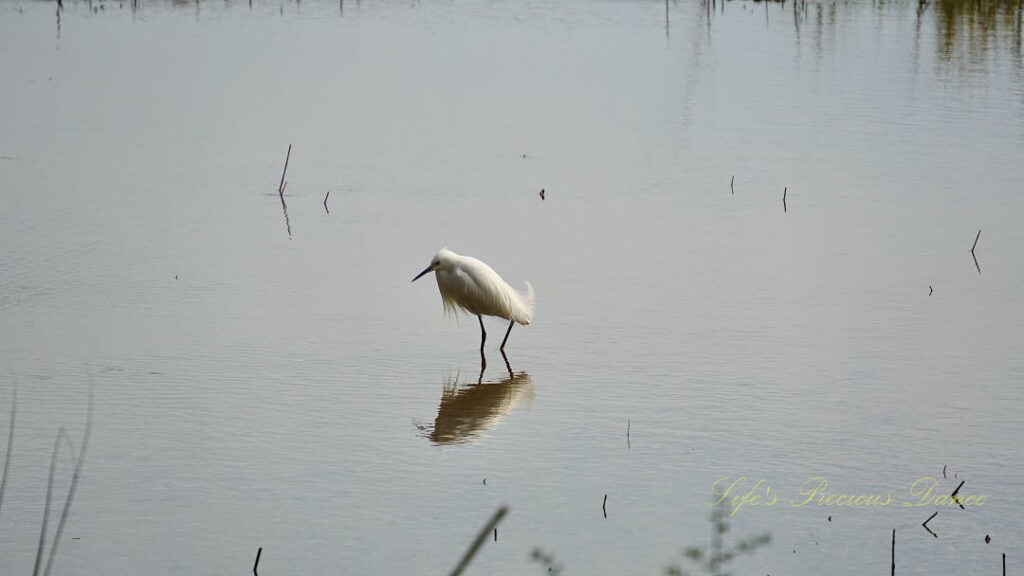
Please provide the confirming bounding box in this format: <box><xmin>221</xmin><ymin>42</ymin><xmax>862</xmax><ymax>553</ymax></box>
<box><xmin>419</xmin><ymin>372</ymin><xmax>534</xmax><ymax>444</ymax></box>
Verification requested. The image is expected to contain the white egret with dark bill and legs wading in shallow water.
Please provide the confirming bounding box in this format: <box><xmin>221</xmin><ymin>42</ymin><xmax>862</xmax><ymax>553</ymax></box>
<box><xmin>413</xmin><ymin>248</ymin><xmax>536</xmax><ymax>364</ymax></box>
